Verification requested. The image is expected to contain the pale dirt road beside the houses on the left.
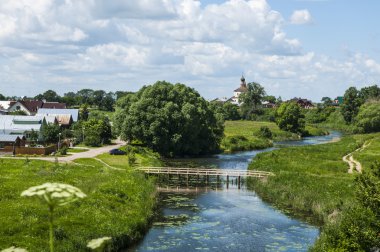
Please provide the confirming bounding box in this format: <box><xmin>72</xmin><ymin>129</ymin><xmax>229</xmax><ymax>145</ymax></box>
<box><xmin>1</xmin><ymin>139</ymin><xmax>126</xmax><ymax>163</ymax></box>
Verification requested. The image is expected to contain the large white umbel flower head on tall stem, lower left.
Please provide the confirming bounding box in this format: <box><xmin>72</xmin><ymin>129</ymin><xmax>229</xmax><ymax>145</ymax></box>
<box><xmin>21</xmin><ymin>183</ymin><xmax>86</xmax><ymax>207</ymax></box>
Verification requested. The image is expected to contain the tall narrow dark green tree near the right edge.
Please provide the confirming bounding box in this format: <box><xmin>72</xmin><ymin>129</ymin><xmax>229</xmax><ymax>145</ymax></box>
<box><xmin>341</xmin><ymin>87</ymin><xmax>362</xmax><ymax>124</ymax></box>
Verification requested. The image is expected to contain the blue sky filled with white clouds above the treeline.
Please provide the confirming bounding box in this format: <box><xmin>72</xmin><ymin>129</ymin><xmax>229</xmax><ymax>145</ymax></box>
<box><xmin>0</xmin><ymin>0</ymin><xmax>380</xmax><ymax>101</ymax></box>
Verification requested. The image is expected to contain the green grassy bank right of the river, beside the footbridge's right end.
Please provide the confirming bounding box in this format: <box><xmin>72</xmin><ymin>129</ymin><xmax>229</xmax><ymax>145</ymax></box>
<box><xmin>249</xmin><ymin>134</ymin><xmax>380</xmax><ymax>224</ymax></box>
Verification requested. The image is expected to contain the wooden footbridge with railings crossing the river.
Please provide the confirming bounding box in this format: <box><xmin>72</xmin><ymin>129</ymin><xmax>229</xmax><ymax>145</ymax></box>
<box><xmin>137</xmin><ymin>167</ymin><xmax>274</xmax><ymax>188</ymax></box>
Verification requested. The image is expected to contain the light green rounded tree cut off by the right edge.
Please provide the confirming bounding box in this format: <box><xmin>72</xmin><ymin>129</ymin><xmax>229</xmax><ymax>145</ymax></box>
<box><xmin>355</xmin><ymin>101</ymin><xmax>380</xmax><ymax>133</ymax></box>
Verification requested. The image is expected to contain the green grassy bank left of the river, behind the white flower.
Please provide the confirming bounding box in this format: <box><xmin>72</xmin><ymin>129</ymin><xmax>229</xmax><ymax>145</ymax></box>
<box><xmin>0</xmin><ymin>149</ymin><xmax>159</xmax><ymax>251</ymax></box>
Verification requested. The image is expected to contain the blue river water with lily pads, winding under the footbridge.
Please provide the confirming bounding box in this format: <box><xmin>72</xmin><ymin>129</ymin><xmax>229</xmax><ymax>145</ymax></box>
<box><xmin>130</xmin><ymin>132</ymin><xmax>340</xmax><ymax>252</ymax></box>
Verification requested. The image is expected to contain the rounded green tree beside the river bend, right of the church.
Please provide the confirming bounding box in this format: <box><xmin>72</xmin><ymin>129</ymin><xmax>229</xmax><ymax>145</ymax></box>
<box><xmin>276</xmin><ymin>102</ymin><xmax>305</xmax><ymax>134</ymax></box>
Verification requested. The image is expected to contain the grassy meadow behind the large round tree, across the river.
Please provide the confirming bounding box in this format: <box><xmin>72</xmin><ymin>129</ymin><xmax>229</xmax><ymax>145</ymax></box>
<box><xmin>221</xmin><ymin>121</ymin><xmax>328</xmax><ymax>153</ymax></box>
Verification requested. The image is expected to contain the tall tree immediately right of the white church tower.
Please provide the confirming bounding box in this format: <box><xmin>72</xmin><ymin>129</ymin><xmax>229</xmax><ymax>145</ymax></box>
<box><xmin>239</xmin><ymin>82</ymin><xmax>266</xmax><ymax>118</ymax></box>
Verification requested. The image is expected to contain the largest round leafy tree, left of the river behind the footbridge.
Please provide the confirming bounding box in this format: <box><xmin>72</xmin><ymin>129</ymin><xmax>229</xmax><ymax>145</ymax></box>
<box><xmin>117</xmin><ymin>81</ymin><xmax>223</xmax><ymax>156</ymax></box>
